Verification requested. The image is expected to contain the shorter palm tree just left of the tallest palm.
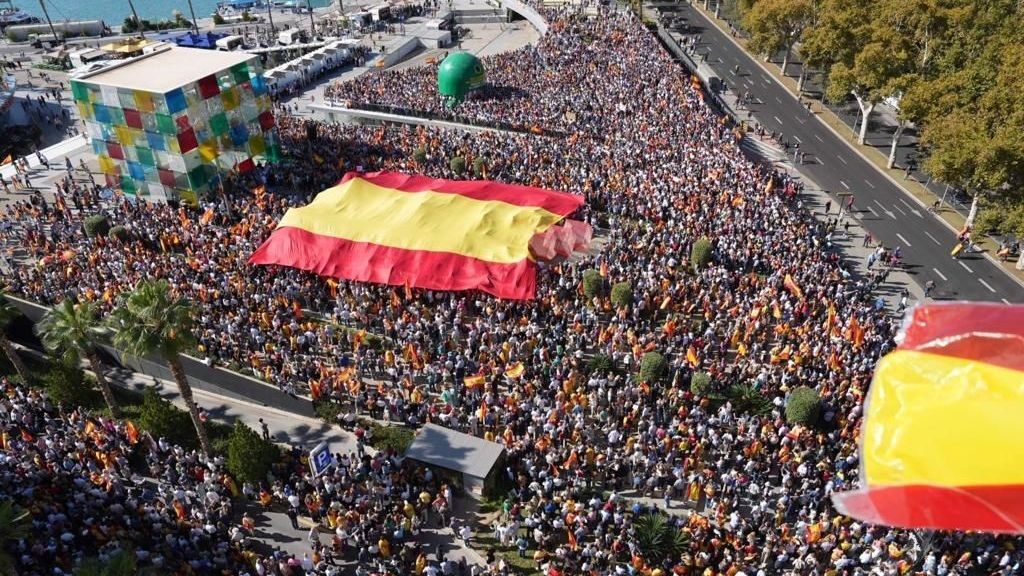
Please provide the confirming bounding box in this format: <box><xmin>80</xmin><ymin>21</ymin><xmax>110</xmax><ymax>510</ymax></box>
<box><xmin>36</xmin><ymin>299</ymin><xmax>121</xmax><ymax>418</ymax></box>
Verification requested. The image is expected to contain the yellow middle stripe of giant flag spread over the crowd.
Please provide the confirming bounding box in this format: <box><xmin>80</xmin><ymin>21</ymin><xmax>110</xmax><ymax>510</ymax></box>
<box><xmin>279</xmin><ymin>178</ymin><xmax>562</xmax><ymax>263</ymax></box>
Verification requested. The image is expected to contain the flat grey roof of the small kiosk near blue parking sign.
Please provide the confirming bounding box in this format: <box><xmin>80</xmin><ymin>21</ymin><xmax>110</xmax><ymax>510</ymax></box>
<box><xmin>406</xmin><ymin>424</ymin><xmax>505</xmax><ymax>478</ymax></box>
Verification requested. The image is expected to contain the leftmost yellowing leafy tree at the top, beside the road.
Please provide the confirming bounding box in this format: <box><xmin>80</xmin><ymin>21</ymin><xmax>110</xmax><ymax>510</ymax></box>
<box><xmin>742</xmin><ymin>0</ymin><xmax>814</xmax><ymax>76</ymax></box>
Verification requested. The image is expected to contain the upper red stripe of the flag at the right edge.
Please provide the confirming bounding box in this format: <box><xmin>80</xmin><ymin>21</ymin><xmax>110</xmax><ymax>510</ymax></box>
<box><xmin>899</xmin><ymin>302</ymin><xmax>1024</xmax><ymax>371</ymax></box>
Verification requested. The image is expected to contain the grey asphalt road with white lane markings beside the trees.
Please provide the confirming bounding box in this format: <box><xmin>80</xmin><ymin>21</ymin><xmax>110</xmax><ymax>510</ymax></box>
<box><xmin>675</xmin><ymin>4</ymin><xmax>1024</xmax><ymax>302</ymax></box>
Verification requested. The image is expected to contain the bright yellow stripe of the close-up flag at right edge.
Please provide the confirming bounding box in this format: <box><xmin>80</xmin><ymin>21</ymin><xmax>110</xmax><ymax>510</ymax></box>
<box><xmin>861</xmin><ymin>349</ymin><xmax>1024</xmax><ymax>486</ymax></box>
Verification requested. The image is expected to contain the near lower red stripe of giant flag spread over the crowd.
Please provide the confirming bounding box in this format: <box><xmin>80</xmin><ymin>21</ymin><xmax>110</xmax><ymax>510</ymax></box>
<box><xmin>249</xmin><ymin>227</ymin><xmax>537</xmax><ymax>300</ymax></box>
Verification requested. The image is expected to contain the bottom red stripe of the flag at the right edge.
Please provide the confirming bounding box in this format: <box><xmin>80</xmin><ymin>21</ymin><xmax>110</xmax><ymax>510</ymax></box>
<box><xmin>833</xmin><ymin>485</ymin><xmax>1024</xmax><ymax>533</ymax></box>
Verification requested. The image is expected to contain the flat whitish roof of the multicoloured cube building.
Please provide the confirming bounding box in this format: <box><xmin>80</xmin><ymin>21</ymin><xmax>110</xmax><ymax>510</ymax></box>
<box><xmin>76</xmin><ymin>47</ymin><xmax>256</xmax><ymax>94</ymax></box>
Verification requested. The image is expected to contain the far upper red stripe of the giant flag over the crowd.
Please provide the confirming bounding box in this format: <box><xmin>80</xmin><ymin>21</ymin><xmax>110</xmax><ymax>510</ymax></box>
<box><xmin>341</xmin><ymin>172</ymin><xmax>584</xmax><ymax>216</ymax></box>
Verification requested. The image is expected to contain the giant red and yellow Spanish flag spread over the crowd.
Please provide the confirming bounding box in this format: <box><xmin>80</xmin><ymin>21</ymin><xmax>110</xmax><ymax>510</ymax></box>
<box><xmin>249</xmin><ymin>172</ymin><xmax>583</xmax><ymax>299</ymax></box>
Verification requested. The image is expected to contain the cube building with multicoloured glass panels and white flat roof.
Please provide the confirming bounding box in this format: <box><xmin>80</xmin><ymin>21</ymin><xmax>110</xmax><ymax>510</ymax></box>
<box><xmin>71</xmin><ymin>47</ymin><xmax>281</xmax><ymax>204</ymax></box>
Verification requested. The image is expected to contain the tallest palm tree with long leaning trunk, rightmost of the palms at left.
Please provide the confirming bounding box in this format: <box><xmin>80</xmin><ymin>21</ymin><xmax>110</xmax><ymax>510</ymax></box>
<box><xmin>111</xmin><ymin>280</ymin><xmax>210</xmax><ymax>456</ymax></box>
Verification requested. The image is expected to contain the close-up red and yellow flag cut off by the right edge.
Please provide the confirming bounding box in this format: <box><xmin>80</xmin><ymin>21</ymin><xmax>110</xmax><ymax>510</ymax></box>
<box><xmin>834</xmin><ymin>302</ymin><xmax>1024</xmax><ymax>533</ymax></box>
